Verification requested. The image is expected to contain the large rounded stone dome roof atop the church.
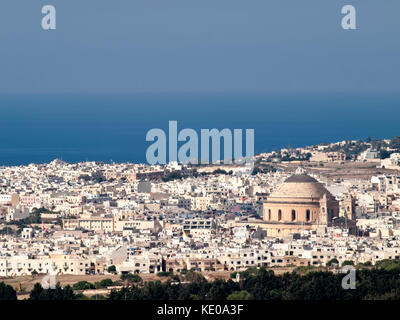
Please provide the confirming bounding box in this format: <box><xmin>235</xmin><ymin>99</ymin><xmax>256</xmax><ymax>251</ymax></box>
<box><xmin>269</xmin><ymin>173</ymin><xmax>332</xmax><ymax>200</ymax></box>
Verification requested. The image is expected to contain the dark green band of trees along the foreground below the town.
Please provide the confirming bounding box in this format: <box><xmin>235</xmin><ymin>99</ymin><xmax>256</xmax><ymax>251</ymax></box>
<box><xmin>0</xmin><ymin>260</ymin><xmax>400</xmax><ymax>300</ymax></box>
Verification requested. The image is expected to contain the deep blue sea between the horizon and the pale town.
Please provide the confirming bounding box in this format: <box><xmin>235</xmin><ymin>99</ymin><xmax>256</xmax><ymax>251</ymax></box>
<box><xmin>0</xmin><ymin>93</ymin><xmax>400</xmax><ymax>165</ymax></box>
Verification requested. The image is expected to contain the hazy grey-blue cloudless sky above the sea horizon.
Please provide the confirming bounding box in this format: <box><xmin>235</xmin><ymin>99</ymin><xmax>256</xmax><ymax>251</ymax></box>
<box><xmin>0</xmin><ymin>0</ymin><xmax>400</xmax><ymax>94</ymax></box>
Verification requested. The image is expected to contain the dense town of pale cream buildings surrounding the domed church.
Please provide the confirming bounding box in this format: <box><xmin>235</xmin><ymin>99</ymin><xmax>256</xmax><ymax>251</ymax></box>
<box><xmin>0</xmin><ymin>138</ymin><xmax>400</xmax><ymax>278</ymax></box>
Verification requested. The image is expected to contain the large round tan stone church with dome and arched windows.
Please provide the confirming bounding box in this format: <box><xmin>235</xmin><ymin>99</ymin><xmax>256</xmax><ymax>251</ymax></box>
<box><xmin>263</xmin><ymin>170</ymin><xmax>352</xmax><ymax>237</ymax></box>
